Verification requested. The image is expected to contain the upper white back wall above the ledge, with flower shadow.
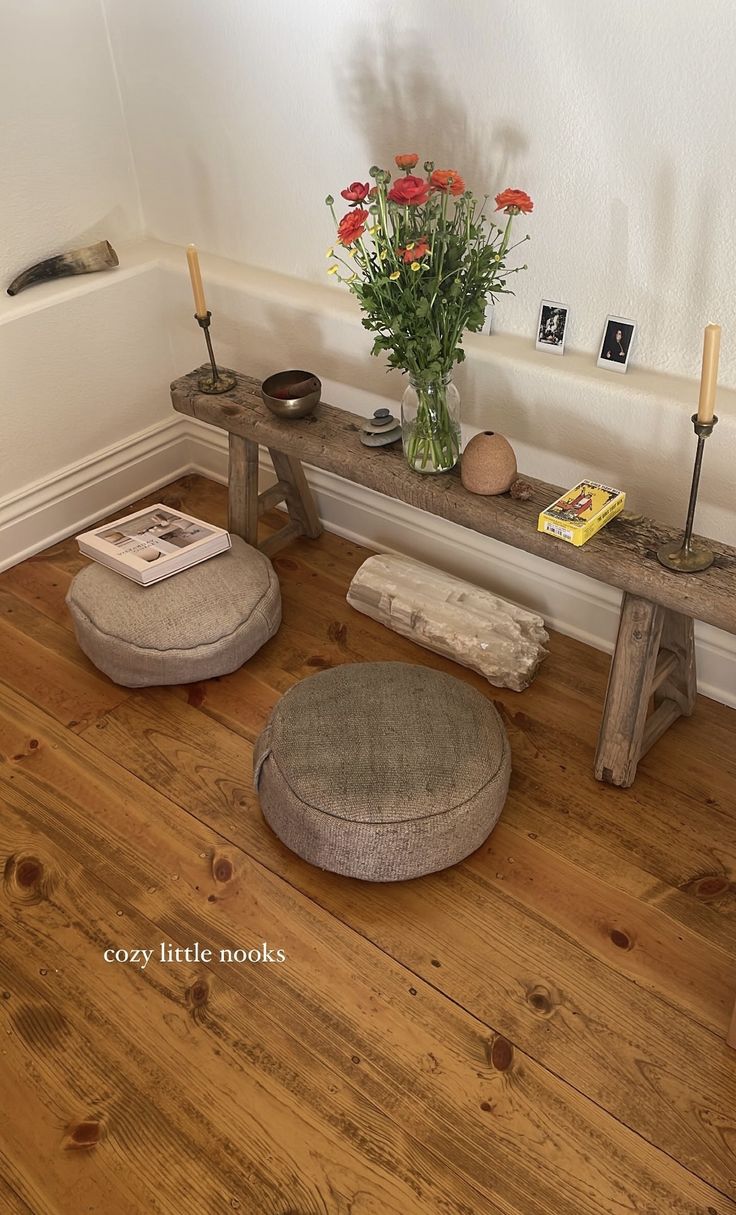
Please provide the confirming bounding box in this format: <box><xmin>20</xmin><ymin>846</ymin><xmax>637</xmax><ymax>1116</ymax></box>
<box><xmin>106</xmin><ymin>0</ymin><xmax>736</xmax><ymax>386</ymax></box>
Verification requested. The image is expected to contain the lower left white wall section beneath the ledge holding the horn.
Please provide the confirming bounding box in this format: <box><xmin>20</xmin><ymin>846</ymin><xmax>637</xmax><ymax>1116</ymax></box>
<box><xmin>0</xmin><ymin>262</ymin><xmax>171</xmax><ymax>505</ymax></box>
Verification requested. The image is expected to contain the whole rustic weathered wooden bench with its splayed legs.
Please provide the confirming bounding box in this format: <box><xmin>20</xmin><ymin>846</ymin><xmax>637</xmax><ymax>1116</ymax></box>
<box><xmin>171</xmin><ymin>368</ymin><xmax>736</xmax><ymax>786</ymax></box>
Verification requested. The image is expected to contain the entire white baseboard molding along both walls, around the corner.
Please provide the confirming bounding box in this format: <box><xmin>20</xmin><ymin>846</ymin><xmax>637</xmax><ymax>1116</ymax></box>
<box><xmin>0</xmin><ymin>414</ymin><xmax>736</xmax><ymax>707</ymax></box>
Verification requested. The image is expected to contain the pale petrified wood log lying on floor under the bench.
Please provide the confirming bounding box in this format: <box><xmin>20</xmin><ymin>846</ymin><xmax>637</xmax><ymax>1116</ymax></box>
<box><xmin>347</xmin><ymin>553</ymin><xmax>549</xmax><ymax>691</ymax></box>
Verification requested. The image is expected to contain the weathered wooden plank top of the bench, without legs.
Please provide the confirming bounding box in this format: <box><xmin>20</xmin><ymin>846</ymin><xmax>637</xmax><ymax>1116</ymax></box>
<box><xmin>171</xmin><ymin>368</ymin><xmax>736</xmax><ymax>633</ymax></box>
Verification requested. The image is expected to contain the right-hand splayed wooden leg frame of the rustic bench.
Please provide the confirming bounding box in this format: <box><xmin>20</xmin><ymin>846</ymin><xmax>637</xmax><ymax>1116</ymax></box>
<box><xmin>595</xmin><ymin>594</ymin><xmax>696</xmax><ymax>787</ymax></box>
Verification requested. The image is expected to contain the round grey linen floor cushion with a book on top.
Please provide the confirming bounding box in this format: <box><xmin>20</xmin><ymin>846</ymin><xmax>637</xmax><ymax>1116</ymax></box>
<box><xmin>67</xmin><ymin>536</ymin><xmax>281</xmax><ymax>688</ymax></box>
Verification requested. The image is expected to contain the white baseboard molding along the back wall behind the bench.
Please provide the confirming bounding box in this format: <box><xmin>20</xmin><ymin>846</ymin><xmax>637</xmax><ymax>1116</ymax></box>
<box><xmin>187</xmin><ymin>422</ymin><xmax>736</xmax><ymax>708</ymax></box>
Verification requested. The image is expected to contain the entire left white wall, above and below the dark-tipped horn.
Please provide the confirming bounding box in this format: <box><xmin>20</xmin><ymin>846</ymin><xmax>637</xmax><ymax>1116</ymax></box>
<box><xmin>0</xmin><ymin>0</ymin><xmax>170</xmax><ymax>507</ymax></box>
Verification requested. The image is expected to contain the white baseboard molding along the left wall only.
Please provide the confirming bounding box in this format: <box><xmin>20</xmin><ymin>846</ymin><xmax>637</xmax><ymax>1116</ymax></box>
<box><xmin>0</xmin><ymin>414</ymin><xmax>192</xmax><ymax>570</ymax></box>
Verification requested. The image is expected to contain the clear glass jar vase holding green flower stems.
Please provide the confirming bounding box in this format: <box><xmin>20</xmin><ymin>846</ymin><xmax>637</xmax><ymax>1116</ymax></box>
<box><xmin>401</xmin><ymin>372</ymin><xmax>460</xmax><ymax>473</ymax></box>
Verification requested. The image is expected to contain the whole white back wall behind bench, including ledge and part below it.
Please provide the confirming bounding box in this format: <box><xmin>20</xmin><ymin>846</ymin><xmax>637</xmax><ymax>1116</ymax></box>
<box><xmin>106</xmin><ymin>0</ymin><xmax>736</xmax><ymax>551</ymax></box>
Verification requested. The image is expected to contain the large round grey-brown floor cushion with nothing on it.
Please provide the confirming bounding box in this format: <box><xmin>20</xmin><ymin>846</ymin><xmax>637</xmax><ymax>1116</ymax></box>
<box><xmin>254</xmin><ymin>662</ymin><xmax>511</xmax><ymax>882</ymax></box>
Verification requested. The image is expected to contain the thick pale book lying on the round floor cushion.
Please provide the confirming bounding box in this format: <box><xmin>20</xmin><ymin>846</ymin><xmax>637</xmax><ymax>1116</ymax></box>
<box><xmin>77</xmin><ymin>503</ymin><xmax>231</xmax><ymax>586</ymax></box>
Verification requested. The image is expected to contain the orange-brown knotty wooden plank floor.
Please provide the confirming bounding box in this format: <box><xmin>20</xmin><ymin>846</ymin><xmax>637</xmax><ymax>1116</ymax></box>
<box><xmin>0</xmin><ymin>477</ymin><xmax>736</xmax><ymax>1215</ymax></box>
